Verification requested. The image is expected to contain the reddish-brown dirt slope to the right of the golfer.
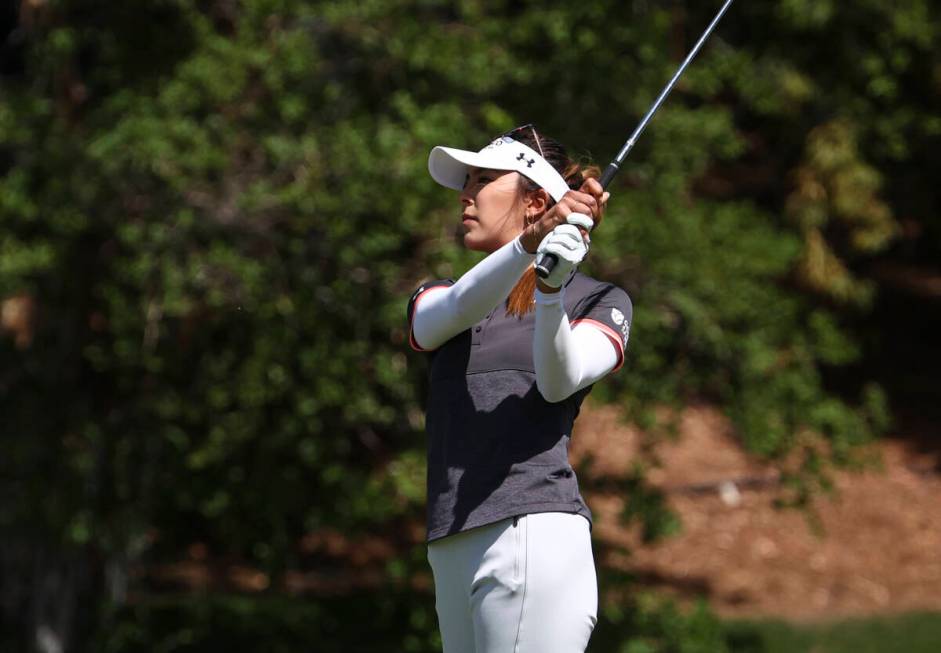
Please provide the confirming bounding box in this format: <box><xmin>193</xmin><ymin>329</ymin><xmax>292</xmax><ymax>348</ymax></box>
<box><xmin>572</xmin><ymin>405</ymin><xmax>941</xmax><ymax>621</ymax></box>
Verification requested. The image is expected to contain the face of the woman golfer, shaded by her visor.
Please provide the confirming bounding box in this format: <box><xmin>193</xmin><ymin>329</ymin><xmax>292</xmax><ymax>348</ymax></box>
<box><xmin>461</xmin><ymin>168</ymin><xmax>526</xmax><ymax>253</ymax></box>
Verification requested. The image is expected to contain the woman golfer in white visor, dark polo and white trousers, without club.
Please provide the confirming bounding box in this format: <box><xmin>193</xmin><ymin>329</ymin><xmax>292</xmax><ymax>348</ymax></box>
<box><xmin>408</xmin><ymin>125</ymin><xmax>631</xmax><ymax>653</ymax></box>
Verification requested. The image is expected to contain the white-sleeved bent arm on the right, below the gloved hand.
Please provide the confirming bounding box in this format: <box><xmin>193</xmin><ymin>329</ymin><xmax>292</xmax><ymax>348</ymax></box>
<box><xmin>533</xmin><ymin>290</ymin><xmax>624</xmax><ymax>403</ymax></box>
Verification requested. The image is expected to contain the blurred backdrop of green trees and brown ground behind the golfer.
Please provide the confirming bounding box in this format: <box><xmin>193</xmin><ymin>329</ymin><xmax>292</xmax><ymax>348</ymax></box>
<box><xmin>0</xmin><ymin>0</ymin><xmax>941</xmax><ymax>653</ymax></box>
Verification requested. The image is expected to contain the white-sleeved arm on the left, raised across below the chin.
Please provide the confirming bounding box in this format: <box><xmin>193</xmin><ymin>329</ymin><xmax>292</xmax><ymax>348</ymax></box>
<box><xmin>411</xmin><ymin>238</ymin><xmax>535</xmax><ymax>351</ymax></box>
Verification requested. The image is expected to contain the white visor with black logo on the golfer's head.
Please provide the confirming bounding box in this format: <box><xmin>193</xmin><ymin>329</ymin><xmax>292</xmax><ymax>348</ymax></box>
<box><xmin>428</xmin><ymin>136</ymin><xmax>571</xmax><ymax>202</ymax></box>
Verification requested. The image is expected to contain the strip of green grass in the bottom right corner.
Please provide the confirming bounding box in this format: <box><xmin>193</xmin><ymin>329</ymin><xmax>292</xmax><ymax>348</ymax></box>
<box><xmin>725</xmin><ymin>612</ymin><xmax>941</xmax><ymax>653</ymax></box>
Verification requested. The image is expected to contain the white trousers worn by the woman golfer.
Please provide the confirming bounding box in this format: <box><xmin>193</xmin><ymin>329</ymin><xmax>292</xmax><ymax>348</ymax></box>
<box><xmin>428</xmin><ymin>512</ymin><xmax>598</xmax><ymax>653</ymax></box>
